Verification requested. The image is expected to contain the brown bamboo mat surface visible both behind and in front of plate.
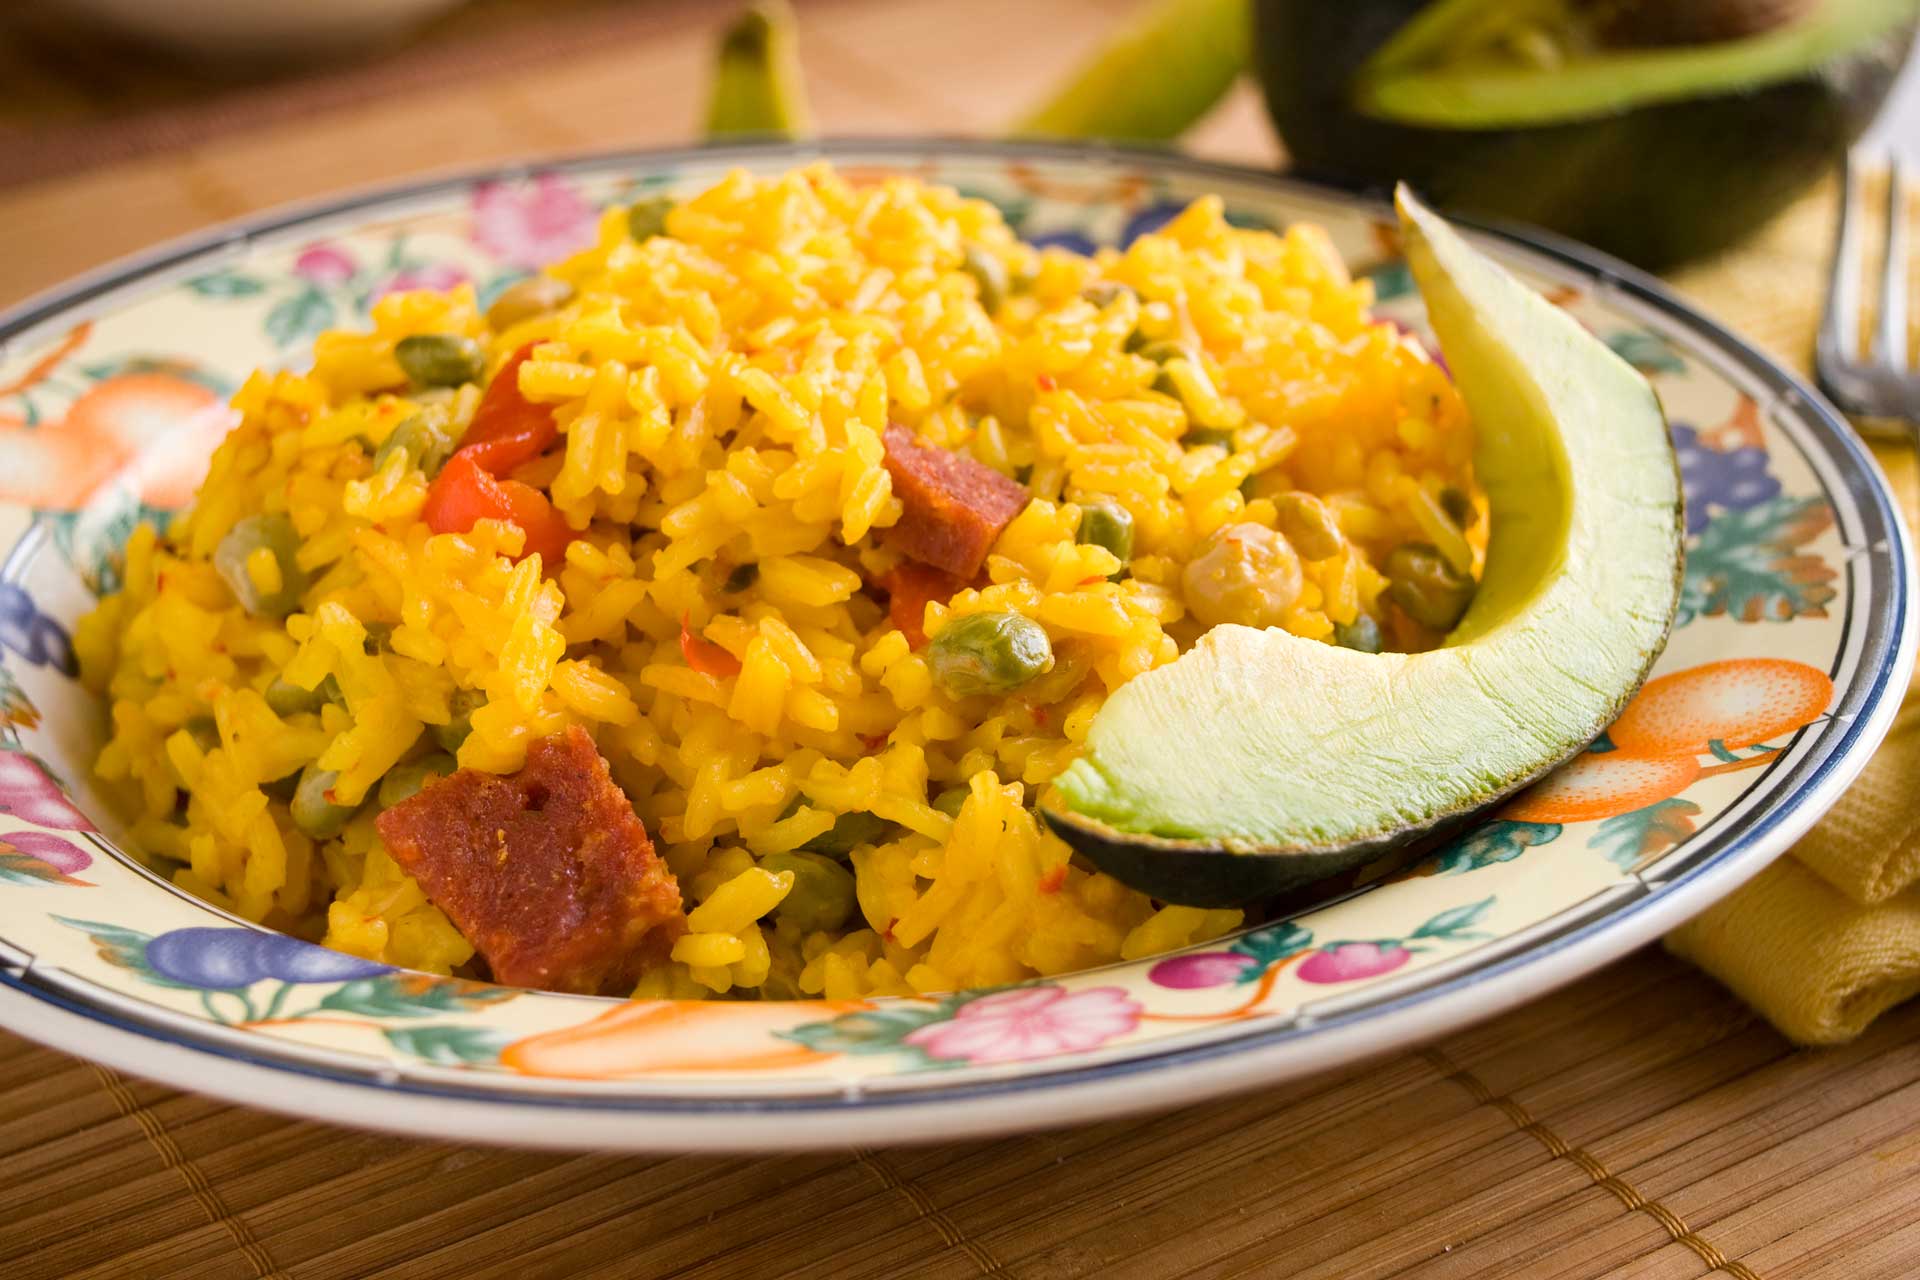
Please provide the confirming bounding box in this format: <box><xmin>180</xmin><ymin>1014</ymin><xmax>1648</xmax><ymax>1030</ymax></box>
<box><xmin>0</xmin><ymin>0</ymin><xmax>1920</xmax><ymax>1280</ymax></box>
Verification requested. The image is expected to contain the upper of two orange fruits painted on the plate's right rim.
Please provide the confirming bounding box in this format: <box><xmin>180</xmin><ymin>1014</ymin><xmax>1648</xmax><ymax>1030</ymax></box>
<box><xmin>1607</xmin><ymin>658</ymin><xmax>1834</xmax><ymax>754</ymax></box>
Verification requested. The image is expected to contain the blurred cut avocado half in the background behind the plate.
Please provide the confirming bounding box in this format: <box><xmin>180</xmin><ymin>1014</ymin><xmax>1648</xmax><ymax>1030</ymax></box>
<box><xmin>1254</xmin><ymin>0</ymin><xmax>1920</xmax><ymax>269</ymax></box>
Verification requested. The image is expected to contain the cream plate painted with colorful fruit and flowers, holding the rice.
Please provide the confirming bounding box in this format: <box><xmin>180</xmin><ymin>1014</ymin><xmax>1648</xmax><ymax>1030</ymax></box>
<box><xmin>0</xmin><ymin>142</ymin><xmax>1914</xmax><ymax>1150</ymax></box>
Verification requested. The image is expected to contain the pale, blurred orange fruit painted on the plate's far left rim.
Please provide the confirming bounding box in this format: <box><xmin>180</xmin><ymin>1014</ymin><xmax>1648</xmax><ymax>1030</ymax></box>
<box><xmin>0</xmin><ymin>372</ymin><xmax>232</xmax><ymax>510</ymax></box>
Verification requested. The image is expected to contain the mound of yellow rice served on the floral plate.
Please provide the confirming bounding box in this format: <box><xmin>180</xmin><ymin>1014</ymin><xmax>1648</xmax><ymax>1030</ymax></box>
<box><xmin>77</xmin><ymin>167</ymin><xmax>1484</xmax><ymax>998</ymax></box>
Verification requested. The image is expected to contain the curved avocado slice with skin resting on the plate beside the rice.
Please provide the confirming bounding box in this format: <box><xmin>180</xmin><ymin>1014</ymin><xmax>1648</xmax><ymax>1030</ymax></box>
<box><xmin>1043</xmin><ymin>188</ymin><xmax>1682</xmax><ymax>906</ymax></box>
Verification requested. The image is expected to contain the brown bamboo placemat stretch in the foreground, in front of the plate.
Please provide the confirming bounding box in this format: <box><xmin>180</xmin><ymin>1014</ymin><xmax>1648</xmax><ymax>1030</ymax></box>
<box><xmin>11</xmin><ymin>952</ymin><xmax>1920</xmax><ymax>1280</ymax></box>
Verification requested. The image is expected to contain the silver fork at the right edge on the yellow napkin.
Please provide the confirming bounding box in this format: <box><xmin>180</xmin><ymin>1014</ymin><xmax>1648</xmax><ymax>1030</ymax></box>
<box><xmin>1814</xmin><ymin>155</ymin><xmax>1920</xmax><ymax>435</ymax></box>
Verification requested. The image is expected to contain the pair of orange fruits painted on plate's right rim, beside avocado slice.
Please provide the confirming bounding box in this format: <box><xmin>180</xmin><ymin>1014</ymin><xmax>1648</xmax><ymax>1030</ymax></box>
<box><xmin>1500</xmin><ymin>658</ymin><xmax>1834</xmax><ymax>823</ymax></box>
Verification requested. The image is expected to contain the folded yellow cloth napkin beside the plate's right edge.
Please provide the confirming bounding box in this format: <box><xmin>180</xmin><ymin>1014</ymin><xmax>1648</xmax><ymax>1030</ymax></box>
<box><xmin>1667</xmin><ymin>447</ymin><xmax>1920</xmax><ymax>1044</ymax></box>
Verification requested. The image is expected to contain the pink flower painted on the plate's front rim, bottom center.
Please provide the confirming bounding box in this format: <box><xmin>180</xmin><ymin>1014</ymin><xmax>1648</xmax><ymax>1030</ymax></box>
<box><xmin>904</xmin><ymin>986</ymin><xmax>1140</xmax><ymax>1065</ymax></box>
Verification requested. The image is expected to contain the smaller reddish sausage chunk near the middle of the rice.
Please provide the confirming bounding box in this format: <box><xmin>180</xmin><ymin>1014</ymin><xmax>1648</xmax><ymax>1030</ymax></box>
<box><xmin>881</xmin><ymin>426</ymin><xmax>1027</xmax><ymax>581</ymax></box>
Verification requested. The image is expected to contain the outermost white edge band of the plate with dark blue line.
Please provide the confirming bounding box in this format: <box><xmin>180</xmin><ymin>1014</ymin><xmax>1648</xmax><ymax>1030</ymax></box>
<box><xmin>0</xmin><ymin>138</ymin><xmax>1916</xmax><ymax>1150</ymax></box>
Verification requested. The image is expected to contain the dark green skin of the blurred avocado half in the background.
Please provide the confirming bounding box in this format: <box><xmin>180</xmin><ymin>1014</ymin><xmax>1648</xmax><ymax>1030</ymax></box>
<box><xmin>1254</xmin><ymin>0</ymin><xmax>1914</xmax><ymax>271</ymax></box>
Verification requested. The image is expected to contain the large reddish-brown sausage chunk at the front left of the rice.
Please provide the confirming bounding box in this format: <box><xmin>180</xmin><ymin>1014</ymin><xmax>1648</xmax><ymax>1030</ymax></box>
<box><xmin>376</xmin><ymin>725</ymin><xmax>687</xmax><ymax>996</ymax></box>
